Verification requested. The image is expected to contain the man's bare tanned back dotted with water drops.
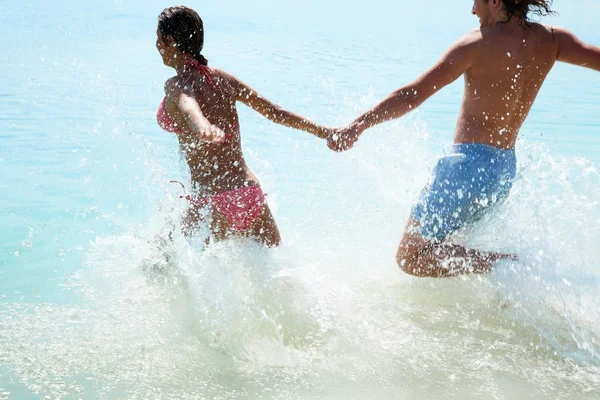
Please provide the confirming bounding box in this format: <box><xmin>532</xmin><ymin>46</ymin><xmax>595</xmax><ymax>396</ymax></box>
<box><xmin>454</xmin><ymin>20</ymin><xmax>557</xmax><ymax>148</ymax></box>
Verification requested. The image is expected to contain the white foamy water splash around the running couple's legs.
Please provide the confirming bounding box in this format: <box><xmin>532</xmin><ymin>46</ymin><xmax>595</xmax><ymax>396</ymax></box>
<box><xmin>0</xmin><ymin>125</ymin><xmax>600</xmax><ymax>399</ymax></box>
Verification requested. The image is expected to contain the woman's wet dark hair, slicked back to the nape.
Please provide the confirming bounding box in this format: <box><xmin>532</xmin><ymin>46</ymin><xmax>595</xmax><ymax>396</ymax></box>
<box><xmin>158</xmin><ymin>6</ymin><xmax>208</xmax><ymax>65</ymax></box>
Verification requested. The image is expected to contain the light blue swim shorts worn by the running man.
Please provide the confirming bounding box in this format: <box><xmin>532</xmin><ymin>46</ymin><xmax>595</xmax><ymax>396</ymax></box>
<box><xmin>411</xmin><ymin>143</ymin><xmax>517</xmax><ymax>242</ymax></box>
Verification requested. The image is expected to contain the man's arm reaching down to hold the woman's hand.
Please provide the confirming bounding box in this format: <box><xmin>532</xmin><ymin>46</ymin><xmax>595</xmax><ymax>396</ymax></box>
<box><xmin>329</xmin><ymin>31</ymin><xmax>481</xmax><ymax>150</ymax></box>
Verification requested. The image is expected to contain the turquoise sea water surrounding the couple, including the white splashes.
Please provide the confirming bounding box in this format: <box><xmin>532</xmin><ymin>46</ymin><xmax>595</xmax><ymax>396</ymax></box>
<box><xmin>0</xmin><ymin>0</ymin><xmax>600</xmax><ymax>399</ymax></box>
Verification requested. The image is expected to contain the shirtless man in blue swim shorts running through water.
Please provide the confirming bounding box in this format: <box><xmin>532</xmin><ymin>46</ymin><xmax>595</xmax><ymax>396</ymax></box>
<box><xmin>328</xmin><ymin>0</ymin><xmax>600</xmax><ymax>277</ymax></box>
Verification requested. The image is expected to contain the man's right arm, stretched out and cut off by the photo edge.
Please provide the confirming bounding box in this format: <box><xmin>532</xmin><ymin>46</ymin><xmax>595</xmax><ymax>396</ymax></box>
<box><xmin>552</xmin><ymin>27</ymin><xmax>600</xmax><ymax>71</ymax></box>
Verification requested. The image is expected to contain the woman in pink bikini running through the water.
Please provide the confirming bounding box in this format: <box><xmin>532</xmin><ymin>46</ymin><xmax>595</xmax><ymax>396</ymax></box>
<box><xmin>156</xmin><ymin>6</ymin><xmax>329</xmax><ymax>246</ymax></box>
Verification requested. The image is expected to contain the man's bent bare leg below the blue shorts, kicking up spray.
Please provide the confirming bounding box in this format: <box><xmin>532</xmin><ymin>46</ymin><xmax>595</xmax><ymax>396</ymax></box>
<box><xmin>396</xmin><ymin>219</ymin><xmax>517</xmax><ymax>278</ymax></box>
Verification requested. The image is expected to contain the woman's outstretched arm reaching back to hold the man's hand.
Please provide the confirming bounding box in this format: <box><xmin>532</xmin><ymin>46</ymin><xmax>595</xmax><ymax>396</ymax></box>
<box><xmin>230</xmin><ymin>75</ymin><xmax>331</xmax><ymax>139</ymax></box>
